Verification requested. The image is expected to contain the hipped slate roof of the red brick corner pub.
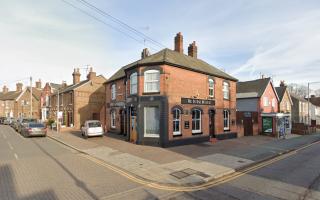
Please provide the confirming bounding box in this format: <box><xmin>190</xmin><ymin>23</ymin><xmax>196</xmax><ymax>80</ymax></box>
<box><xmin>107</xmin><ymin>48</ymin><xmax>238</xmax><ymax>82</ymax></box>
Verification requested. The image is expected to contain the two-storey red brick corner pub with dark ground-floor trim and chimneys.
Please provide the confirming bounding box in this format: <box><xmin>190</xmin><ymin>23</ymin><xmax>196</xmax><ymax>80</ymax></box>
<box><xmin>105</xmin><ymin>33</ymin><xmax>237</xmax><ymax>147</ymax></box>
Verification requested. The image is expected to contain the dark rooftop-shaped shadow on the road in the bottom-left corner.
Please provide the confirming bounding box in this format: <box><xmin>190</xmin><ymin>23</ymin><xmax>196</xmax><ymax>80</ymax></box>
<box><xmin>0</xmin><ymin>164</ymin><xmax>58</xmax><ymax>200</ymax></box>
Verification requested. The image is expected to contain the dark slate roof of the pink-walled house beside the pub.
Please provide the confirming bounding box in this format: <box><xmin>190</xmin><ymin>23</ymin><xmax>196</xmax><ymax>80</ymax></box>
<box><xmin>237</xmin><ymin>78</ymin><xmax>271</xmax><ymax>98</ymax></box>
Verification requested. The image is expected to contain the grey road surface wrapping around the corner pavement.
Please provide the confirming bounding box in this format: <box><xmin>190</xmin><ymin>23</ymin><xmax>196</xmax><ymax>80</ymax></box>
<box><xmin>0</xmin><ymin>125</ymin><xmax>320</xmax><ymax>200</ymax></box>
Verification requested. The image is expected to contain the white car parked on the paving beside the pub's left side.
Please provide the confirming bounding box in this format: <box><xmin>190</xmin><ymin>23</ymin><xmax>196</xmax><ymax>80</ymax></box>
<box><xmin>81</xmin><ymin>120</ymin><xmax>104</xmax><ymax>138</ymax></box>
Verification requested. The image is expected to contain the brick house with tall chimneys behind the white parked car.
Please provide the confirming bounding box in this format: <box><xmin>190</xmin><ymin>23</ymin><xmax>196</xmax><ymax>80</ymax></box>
<box><xmin>49</xmin><ymin>68</ymin><xmax>107</xmax><ymax>129</ymax></box>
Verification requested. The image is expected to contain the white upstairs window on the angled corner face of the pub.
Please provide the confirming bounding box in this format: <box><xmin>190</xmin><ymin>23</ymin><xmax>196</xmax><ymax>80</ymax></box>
<box><xmin>144</xmin><ymin>70</ymin><xmax>160</xmax><ymax>93</ymax></box>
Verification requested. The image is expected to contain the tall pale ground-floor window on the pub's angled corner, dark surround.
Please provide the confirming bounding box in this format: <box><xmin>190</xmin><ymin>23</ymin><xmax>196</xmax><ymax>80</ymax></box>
<box><xmin>144</xmin><ymin>107</ymin><xmax>160</xmax><ymax>137</ymax></box>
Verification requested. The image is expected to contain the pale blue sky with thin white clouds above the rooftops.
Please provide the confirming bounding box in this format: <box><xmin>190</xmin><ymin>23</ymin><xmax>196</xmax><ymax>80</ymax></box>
<box><xmin>0</xmin><ymin>0</ymin><xmax>320</xmax><ymax>89</ymax></box>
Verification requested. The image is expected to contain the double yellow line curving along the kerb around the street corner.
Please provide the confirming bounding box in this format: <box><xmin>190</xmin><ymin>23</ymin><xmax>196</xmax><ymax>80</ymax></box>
<box><xmin>80</xmin><ymin>141</ymin><xmax>320</xmax><ymax>192</ymax></box>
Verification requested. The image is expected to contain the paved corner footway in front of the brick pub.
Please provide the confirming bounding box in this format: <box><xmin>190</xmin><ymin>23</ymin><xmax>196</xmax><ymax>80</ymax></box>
<box><xmin>48</xmin><ymin>131</ymin><xmax>320</xmax><ymax>186</ymax></box>
